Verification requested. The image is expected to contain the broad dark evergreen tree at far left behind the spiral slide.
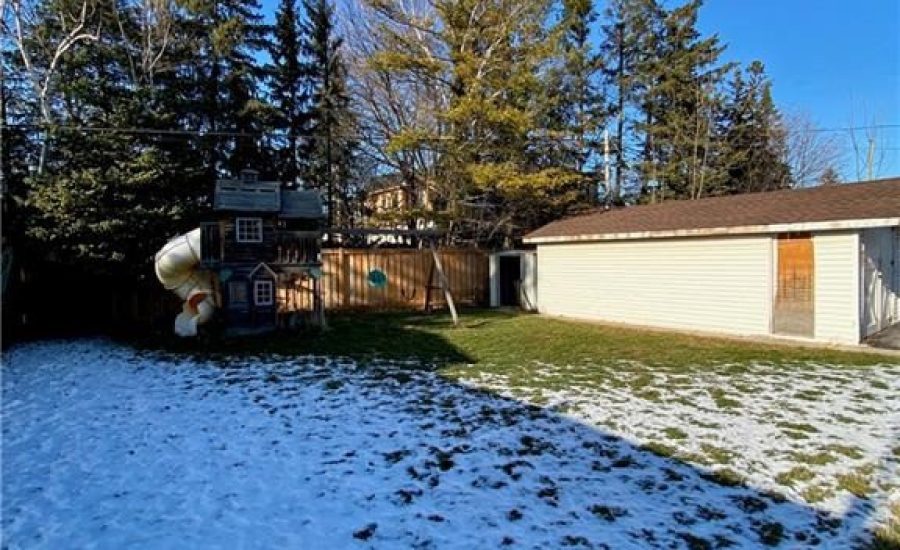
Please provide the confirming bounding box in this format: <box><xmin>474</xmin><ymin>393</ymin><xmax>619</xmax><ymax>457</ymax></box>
<box><xmin>21</xmin><ymin>0</ymin><xmax>205</xmax><ymax>280</ymax></box>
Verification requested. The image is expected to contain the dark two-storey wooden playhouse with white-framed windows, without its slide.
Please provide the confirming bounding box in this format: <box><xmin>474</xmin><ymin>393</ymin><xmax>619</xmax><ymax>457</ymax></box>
<box><xmin>200</xmin><ymin>170</ymin><xmax>324</xmax><ymax>333</ymax></box>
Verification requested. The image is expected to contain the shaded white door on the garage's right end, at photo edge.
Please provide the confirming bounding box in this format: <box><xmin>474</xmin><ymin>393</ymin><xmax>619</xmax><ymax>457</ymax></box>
<box><xmin>862</xmin><ymin>228</ymin><xmax>896</xmax><ymax>336</ymax></box>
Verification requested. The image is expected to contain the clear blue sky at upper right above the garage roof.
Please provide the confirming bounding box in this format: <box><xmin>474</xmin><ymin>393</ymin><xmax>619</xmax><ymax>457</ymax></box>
<box><xmin>700</xmin><ymin>0</ymin><xmax>900</xmax><ymax>179</ymax></box>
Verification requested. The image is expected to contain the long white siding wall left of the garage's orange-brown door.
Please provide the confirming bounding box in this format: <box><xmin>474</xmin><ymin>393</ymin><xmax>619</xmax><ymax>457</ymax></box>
<box><xmin>537</xmin><ymin>235</ymin><xmax>772</xmax><ymax>334</ymax></box>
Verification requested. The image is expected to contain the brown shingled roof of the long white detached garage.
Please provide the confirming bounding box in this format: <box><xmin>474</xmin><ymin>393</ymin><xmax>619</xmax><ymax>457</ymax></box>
<box><xmin>525</xmin><ymin>178</ymin><xmax>900</xmax><ymax>243</ymax></box>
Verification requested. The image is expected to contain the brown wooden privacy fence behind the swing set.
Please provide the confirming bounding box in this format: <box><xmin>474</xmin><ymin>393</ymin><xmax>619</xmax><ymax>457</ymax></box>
<box><xmin>279</xmin><ymin>249</ymin><xmax>489</xmax><ymax>310</ymax></box>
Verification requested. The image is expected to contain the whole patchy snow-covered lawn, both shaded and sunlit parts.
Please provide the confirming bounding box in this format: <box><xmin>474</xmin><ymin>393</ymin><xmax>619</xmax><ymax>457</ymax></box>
<box><xmin>2</xmin><ymin>341</ymin><xmax>900</xmax><ymax>549</ymax></box>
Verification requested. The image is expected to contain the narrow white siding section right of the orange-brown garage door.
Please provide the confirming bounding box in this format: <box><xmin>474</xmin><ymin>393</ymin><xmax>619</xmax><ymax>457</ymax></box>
<box><xmin>813</xmin><ymin>231</ymin><xmax>861</xmax><ymax>344</ymax></box>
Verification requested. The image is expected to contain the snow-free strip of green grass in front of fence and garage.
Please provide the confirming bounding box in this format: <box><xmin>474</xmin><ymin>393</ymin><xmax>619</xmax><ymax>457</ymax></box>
<box><xmin>138</xmin><ymin>310</ymin><xmax>884</xmax><ymax>374</ymax></box>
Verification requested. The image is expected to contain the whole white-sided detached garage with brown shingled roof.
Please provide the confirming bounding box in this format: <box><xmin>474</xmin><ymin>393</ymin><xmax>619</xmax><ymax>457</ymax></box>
<box><xmin>525</xmin><ymin>179</ymin><xmax>900</xmax><ymax>344</ymax></box>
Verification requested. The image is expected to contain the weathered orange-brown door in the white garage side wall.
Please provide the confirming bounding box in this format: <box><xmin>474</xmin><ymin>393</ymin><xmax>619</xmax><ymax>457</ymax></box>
<box><xmin>772</xmin><ymin>233</ymin><xmax>815</xmax><ymax>337</ymax></box>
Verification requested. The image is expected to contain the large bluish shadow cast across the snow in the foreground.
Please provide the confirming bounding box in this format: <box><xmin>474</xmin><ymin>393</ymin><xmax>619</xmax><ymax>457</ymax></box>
<box><xmin>2</xmin><ymin>327</ymin><xmax>892</xmax><ymax>548</ymax></box>
